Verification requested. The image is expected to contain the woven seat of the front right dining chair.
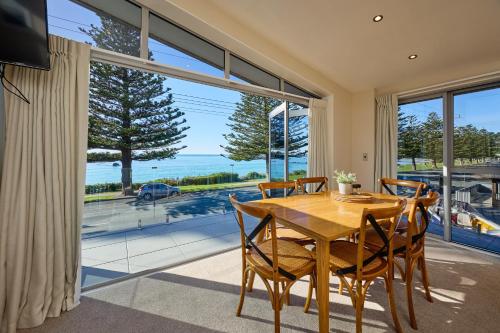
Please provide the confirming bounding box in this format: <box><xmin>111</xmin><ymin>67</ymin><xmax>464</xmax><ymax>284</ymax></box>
<box><xmin>330</xmin><ymin>241</ymin><xmax>387</xmax><ymax>277</ymax></box>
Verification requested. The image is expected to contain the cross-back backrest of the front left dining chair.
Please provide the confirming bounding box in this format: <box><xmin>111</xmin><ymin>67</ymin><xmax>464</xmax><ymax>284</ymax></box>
<box><xmin>229</xmin><ymin>194</ymin><xmax>296</xmax><ymax>281</ymax></box>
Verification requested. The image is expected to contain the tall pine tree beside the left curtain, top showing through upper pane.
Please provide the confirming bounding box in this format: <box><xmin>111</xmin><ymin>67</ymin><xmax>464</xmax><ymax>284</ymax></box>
<box><xmin>82</xmin><ymin>16</ymin><xmax>189</xmax><ymax>194</ymax></box>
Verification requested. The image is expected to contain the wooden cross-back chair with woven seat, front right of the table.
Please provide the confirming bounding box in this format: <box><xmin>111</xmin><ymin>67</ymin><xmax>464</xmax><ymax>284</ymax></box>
<box><xmin>306</xmin><ymin>200</ymin><xmax>406</xmax><ymax>333</ymax></box>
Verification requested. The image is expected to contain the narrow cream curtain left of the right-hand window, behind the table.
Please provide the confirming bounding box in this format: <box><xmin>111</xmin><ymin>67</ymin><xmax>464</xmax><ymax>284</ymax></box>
<box><xmin>374</xmin><ymin>95</ymin><xmax>398</xmax><ymax>189</ymax></box>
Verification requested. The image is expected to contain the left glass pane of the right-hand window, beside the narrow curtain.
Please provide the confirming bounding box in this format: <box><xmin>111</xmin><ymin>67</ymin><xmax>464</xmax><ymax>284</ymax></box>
<box><xmin>397</xmin><ymin>98</ymin><xmax>444</xmax><ymax>235</ymax></box>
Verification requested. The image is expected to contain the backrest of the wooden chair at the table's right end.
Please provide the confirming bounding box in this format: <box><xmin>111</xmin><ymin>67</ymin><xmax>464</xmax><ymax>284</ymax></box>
<box><xmin>406</xmin><ymin>191</ymin><xmax>439</xmax><ymax>248</ymax></box>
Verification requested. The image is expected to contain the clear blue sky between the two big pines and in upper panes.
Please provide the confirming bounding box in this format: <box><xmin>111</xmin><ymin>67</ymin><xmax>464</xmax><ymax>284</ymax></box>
<box><xmin>47</xmin><ymin>0</ymin><xmax>250</xmax><ymax>154</ymax></box>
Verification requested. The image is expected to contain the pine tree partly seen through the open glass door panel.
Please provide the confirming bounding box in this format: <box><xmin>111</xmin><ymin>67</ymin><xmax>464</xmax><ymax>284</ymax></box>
<box><xmin>222</xmin><ymin>93</ymin><xmax>307</xmax><ymax>174</ymax></box>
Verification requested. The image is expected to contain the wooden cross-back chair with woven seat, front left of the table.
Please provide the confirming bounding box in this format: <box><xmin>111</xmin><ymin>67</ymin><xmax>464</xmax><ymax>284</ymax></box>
<box><xmin>229</xmin><ymin>194</ymin><xmax>316</xmax><ymax>332</ymax></box>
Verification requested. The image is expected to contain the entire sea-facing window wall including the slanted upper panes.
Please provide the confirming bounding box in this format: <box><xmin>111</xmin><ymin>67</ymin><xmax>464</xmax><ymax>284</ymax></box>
<box><xmin>48</xmin><ymin>0</ymin><xmax>313</xmax><ymax>287</ymax></box>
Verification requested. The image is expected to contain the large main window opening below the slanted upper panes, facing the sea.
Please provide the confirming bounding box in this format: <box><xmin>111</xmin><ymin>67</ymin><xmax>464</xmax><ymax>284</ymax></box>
<box><xmin>82</xmin><ymin>62</ymin><xmax>307</xmax><ymax>286</ymax></box>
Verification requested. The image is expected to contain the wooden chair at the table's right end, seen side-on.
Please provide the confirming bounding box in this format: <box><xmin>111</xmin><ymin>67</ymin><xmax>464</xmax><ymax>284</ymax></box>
<box><xmin>365</xmin><ymin>191</ymin><xmax>439</xmax><ymax>329</ymax></box>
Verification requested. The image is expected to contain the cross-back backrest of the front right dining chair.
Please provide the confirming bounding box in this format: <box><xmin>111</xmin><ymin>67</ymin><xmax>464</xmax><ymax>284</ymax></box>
<box><xmin>337</xmin><ymin>199</ymin><xmax>406</xmax><ymax>280</ymax></box>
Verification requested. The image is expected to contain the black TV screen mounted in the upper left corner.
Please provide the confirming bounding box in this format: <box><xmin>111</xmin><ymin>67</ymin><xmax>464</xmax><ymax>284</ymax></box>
<box><xmin>0</xmin><ymin>0</ymin><xmax>50</xmax><ymax>69</ymax></box>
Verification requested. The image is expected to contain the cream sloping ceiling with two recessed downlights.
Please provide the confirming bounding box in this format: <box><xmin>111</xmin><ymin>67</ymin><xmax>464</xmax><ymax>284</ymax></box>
<box><xmin>200</xmin><ymin>0</ymin><xmax>500</xmax><ymax>92</ymax></box>
